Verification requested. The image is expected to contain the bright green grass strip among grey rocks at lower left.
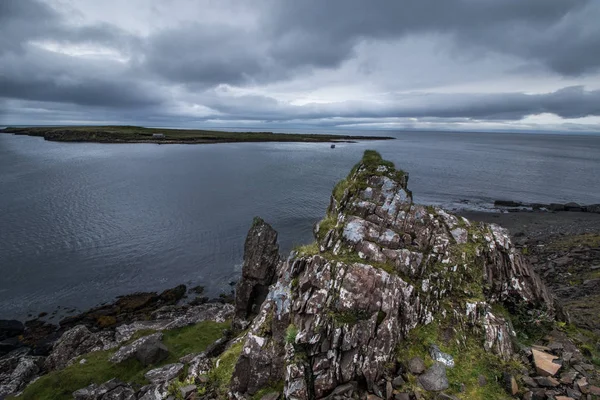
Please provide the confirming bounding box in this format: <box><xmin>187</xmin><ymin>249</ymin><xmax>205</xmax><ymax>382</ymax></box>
<box><xmin>18</xmin><ymin>321</ymin><xmax>229</xmax><ymax>400</ymax></box>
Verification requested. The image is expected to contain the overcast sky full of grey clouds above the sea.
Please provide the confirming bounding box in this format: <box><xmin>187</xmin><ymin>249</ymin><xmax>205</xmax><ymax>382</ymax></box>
<box><xmin>0</xmin><ymin>0</ymin><xmax>600</xmax><ymax>132</ymax></box>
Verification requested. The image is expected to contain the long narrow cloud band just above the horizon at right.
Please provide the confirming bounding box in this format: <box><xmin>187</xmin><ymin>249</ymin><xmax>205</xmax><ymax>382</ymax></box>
<box><xmin>199</xmin><ymin>86</ymin><xmax>600</xmax><ymax>121</ymax></box>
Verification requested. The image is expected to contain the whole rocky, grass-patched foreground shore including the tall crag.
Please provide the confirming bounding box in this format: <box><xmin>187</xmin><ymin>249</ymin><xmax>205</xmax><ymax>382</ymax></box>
<box><xmin>0</xmin><ymin>151</ymin><xmax>600</xmax><ymax>400</ymax></box>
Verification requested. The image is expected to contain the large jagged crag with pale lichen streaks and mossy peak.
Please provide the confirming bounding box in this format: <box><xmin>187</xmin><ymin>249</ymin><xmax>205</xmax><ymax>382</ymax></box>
<box><xmin>231</xmin><ymin>151</ymin><xmax>554</xmax><ymax>399</ymax></box>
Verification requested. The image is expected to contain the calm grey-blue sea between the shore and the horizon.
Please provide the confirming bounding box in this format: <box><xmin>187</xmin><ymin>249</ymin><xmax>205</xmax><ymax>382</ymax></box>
<box><xmin>0</xmin><ymin>131</ymin><xmax>600</xmax><ymax>319</ymax></box>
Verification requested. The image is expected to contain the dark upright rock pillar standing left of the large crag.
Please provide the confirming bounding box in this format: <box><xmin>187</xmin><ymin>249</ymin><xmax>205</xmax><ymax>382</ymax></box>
<box><xmin>235</xmin><ymin>218</ymin><xmax>279</xmax><ymax>328</ymax></box>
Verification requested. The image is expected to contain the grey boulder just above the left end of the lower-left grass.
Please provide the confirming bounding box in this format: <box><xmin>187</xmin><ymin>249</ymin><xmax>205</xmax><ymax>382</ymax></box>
<box><xmin>44</xmin><ymin>325</ymin><xmax>105</xmax><ymax>371</ymax></box>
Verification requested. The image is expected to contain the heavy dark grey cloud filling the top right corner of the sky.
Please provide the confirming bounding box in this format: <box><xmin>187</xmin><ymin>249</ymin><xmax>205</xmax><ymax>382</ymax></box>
<box><xmin>272</xmin><ymin>0</ymin><xmax>600</xmax><ymax>74</ymax></box>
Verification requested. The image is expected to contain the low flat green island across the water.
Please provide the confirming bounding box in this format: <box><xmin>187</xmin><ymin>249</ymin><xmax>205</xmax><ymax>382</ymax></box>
<box><xmin>0</xmin><ymin>126</ymin><xmax>394</xmax><ymax>144</ymax></box>
